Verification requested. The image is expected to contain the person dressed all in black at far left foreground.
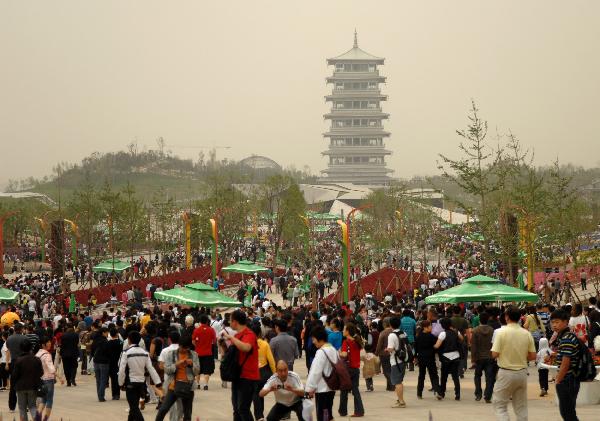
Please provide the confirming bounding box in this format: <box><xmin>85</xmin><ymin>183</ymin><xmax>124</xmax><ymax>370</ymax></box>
<box><xmin>11</xmin><ymin>341</ymin><xmax>44</xmax><ymax>421</ymax></box>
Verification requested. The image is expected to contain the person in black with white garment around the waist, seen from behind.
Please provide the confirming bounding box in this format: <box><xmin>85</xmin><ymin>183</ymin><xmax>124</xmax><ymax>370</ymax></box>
<box><xmin>433</xmin><ymin>318</ymin><xmax>463</xmax><ymax>401</ymax></box>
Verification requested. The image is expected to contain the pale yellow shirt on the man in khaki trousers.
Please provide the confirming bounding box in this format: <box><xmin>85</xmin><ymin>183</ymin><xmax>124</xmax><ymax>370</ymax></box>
<box><xmin>492</xmin><ymin>323</ymin><xmax>535</xmax><ymax>370</ymax></box>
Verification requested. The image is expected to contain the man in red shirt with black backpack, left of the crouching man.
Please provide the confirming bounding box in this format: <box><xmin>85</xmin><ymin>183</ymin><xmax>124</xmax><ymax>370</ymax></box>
<box><xmin>221</xmin><ymin>310</ymin><xmax>260</xmax><ymax>421</ymax></box>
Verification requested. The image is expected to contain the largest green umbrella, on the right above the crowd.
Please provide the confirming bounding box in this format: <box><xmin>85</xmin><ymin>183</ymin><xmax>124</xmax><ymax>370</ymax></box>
<box><xmin>425</xmin><ymin>275</ymin><xmax>539</xmax><ymax>304</ymax></box>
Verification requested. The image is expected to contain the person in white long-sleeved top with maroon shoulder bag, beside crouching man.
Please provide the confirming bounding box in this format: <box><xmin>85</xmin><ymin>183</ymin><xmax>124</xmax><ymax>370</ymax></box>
<box><xmin>305</xmin><ymin>325</ymin><xmax>339</xmax><ymax>421</ymax></box>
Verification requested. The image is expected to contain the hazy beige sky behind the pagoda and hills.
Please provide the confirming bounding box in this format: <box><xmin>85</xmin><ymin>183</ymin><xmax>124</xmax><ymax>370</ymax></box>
<box><xmin>0</xmin><ymin>0</ymin><xmax>600</xmax><ymax>186</ymax></box>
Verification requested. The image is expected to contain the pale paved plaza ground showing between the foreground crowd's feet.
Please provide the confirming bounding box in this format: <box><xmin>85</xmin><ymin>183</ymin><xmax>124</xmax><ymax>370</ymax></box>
<box><xmin>0</xmin><ymin>359</ymin><xmax>600</xmax><ymax>421</ymax></box>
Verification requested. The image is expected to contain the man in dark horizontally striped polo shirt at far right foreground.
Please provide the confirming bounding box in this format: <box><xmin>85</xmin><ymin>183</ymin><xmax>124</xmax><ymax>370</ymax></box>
<box><xmin>550</xmin><ymin>310</ymin><xmax>581</xmax><ymax>421</ymax></box>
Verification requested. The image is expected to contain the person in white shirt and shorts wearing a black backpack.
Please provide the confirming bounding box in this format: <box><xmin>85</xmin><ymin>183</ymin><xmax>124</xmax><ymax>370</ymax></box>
<box><xmin>387</xmin><ymin>317</ymin><xmax>412</xmax><ymax>408</ymax></box>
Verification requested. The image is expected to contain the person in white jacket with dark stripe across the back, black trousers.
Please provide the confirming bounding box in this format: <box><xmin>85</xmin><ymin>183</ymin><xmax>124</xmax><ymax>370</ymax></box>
<box><xmin>119</xmin><ymin>330</ymin><xmax>161</xmax><ymax>421</ymax></box>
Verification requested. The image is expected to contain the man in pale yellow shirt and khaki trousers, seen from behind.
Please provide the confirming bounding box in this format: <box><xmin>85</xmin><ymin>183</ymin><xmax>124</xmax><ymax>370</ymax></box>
<box><xmin>492</xmin><ymin>306</ymin><xmax>536</xmax><ymax>421</ymax></box>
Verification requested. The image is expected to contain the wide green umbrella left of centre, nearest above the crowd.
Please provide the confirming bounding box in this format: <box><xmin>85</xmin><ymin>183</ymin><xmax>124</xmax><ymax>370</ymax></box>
<box><xmin>154</xmin><ymin>283</ymin><xmax>242</xmax><ymax>307</ymax></box>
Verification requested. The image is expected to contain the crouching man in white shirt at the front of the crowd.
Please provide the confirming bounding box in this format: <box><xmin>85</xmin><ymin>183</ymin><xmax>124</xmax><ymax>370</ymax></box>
<box><xmin>258</xmin><ymin>360</ymin><xmax>304</xmax><ymax>421</ymax></box>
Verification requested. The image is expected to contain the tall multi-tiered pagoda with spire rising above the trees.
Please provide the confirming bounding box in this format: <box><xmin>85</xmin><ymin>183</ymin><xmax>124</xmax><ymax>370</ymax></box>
<box><xmin>319</xmin><ymin>31</ymin><xmax>393</xmax><ymax>185</ymax></box>
